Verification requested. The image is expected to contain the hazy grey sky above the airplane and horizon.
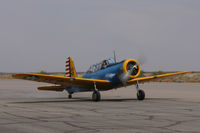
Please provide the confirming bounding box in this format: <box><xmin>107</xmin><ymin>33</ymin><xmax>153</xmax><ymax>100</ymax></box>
<box><xmin>0</xmin><ymin>0</ymin><xmax>200</xmax><ymax>72</ymax></box>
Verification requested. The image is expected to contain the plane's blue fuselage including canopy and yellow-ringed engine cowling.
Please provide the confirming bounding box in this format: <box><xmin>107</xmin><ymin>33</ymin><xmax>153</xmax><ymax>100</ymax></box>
<box><xmin>67</xmin><ymin>59</ymin><xmax>141</xmax><ymax>92</ymax></box>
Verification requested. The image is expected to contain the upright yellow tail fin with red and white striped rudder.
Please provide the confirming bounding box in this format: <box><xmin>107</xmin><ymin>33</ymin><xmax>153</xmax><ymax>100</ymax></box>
<box><xmin>65</xmin><ymin>57</ymin><xmax>77</xmax><ymax>78</ymax></box>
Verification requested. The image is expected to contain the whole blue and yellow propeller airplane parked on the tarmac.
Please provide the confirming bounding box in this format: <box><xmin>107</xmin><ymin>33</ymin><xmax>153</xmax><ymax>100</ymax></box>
<box><xmin>12</xmin><ymin>57</ymin><xmax>191</xmax><ymax>102</ymax></box>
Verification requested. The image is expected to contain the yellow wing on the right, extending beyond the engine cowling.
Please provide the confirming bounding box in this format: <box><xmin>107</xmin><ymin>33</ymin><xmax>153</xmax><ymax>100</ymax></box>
<box><xmin>127</xmin><ymin>71</ymin><xmax>192</xmax><ymax>85</ymax></box>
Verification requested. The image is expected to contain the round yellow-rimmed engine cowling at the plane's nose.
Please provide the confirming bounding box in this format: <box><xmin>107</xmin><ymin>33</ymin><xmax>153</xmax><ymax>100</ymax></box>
<box><xmin>122</xmin><ymin>59</ymin><xmax>141</xmax><ymax>79</ymax></box>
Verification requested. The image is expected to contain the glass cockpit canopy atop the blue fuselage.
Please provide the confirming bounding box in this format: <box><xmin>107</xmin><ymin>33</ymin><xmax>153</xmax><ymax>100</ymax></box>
<box><xmin>87</xmin><ymin>58</ymin><xmax>115</xmax><ymax>73</ymax></box>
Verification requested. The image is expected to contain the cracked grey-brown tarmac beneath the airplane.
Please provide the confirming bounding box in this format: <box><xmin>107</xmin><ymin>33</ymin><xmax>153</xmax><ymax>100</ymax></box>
<box><xmin>0</xmin><ymin>80</ymin><xmax>200</xmax><ymax>133</ymax></box>
